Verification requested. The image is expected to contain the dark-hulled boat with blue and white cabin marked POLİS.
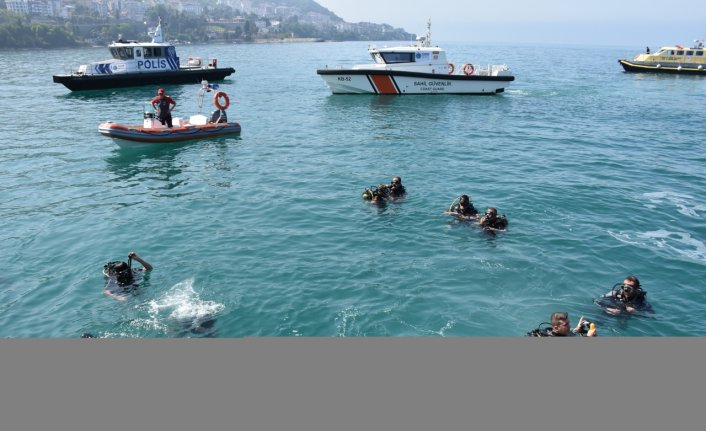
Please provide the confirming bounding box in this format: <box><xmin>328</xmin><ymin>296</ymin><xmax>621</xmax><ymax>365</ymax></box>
<box><xmin>53</xmin><ymin>18</ymin><xmax>235</xmax><ymax>91</ymax></box>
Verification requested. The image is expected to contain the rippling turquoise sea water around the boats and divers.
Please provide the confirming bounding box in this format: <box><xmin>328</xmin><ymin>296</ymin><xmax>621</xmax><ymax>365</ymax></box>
<box><xmin>0</xmin><ymin>41</ymin><xmax>706</xmax><ymax>338</ymax></box>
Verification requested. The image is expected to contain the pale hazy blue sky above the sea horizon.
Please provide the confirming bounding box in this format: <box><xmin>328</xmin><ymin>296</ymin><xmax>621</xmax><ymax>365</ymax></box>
<box><xmin>316</xmin><ymin>0</ymin><xmax>706</xmax><ymax>47</ymax></box>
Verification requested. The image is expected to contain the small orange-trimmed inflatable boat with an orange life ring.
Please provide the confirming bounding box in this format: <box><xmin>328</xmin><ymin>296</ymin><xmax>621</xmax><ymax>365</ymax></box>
<box><xmin>98</xmin><ymin>81</ymin><xmax>240</xmax><ymax>147</ymax></box>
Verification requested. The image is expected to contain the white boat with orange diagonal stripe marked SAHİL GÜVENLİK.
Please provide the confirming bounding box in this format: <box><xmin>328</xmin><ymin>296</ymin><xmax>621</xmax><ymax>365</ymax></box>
<box><xmin>316</xmin><ymin>21</ymin><xmax>515</xmax><ymax>94</ymax></box>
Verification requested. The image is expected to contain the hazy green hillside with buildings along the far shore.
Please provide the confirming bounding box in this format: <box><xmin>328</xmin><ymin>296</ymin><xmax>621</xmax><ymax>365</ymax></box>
<box><xmin>0</xmin><ymin>0</ymin><xmax>414</xmax><ymax>48</ymax></box>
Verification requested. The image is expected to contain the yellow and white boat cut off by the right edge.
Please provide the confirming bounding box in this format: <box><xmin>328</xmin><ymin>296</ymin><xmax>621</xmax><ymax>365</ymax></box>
<box><xmin>618</xmin><ymin>40</ymin><xmax>706</xmax><ymax>75</ymax></box>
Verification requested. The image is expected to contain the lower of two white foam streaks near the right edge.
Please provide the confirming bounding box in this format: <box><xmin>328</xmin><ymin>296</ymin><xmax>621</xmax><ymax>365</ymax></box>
<box><xmin>608</xmin><ymin>229</ymin><xmax>706</xmax><ymax>264</ymax></box>
